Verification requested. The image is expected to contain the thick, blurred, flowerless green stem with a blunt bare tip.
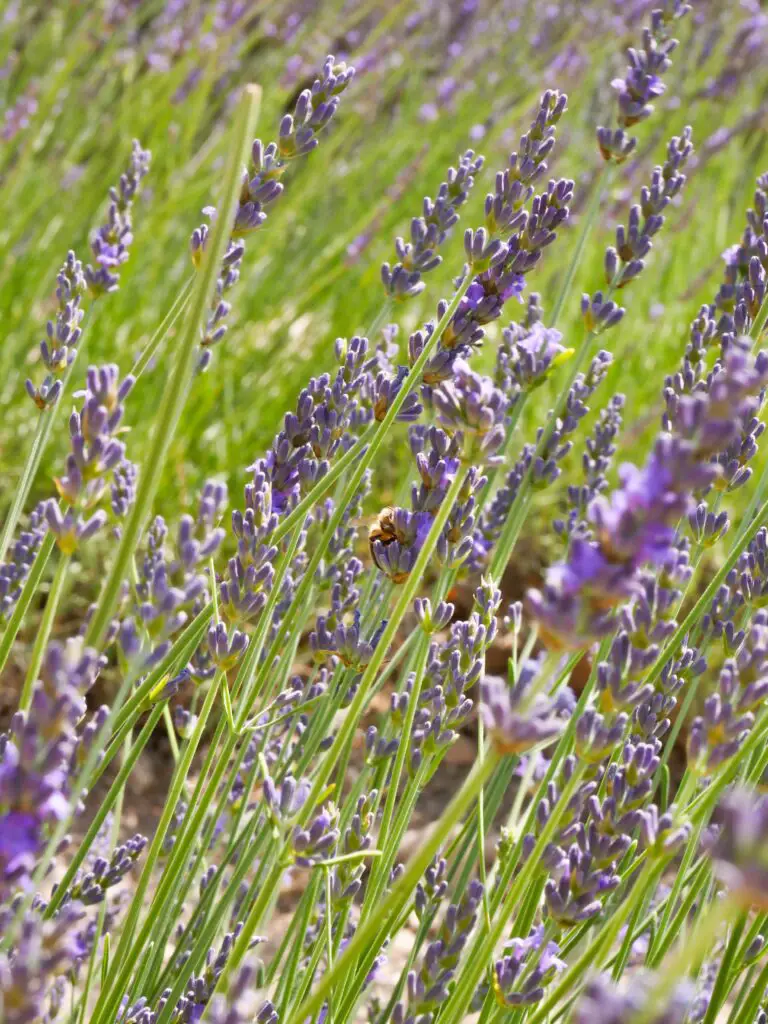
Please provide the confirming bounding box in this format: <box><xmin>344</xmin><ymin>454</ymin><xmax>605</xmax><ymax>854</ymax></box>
<box><xmin>81</xmin><ymin>85</ymin><xmax>261</xmax><ymax>647</ymax></box>
